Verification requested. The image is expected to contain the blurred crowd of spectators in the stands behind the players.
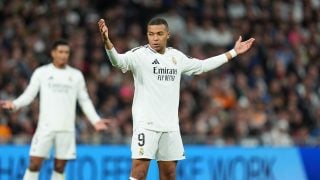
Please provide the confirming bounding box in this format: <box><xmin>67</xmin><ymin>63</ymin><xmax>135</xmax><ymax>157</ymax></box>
<box><xmin>0</xmin><ymin>0</ymin><xmax>320</xmax><ymax>146</ymax></box>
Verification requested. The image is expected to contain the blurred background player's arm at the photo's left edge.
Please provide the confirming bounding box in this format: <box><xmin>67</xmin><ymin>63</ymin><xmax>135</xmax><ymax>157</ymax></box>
<box><xmin>0</xmin><ymin>71</ymin><xmax>41</xmax><ymax>110</ymax></box>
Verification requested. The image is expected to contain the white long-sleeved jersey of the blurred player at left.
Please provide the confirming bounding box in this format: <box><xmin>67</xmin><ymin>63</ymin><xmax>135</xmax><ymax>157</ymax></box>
<box><xmin>13</xmin><ymin>63</ymin><xmax>100</xmax><ymax>131</ymax></box>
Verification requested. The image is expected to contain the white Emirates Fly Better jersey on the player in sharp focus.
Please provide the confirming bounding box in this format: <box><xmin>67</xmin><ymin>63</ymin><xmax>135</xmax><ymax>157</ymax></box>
<box><xmin>107</xmin><ymin>45</ymin><xmax>227</xmax><ymax>132</ymax></box>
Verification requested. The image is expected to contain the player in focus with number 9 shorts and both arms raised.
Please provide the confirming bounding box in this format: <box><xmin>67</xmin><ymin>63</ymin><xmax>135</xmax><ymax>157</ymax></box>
<box><xmin>98</xmin><ymin>17</ymin><xmax>255</xmax><ymax>180</ymax></box>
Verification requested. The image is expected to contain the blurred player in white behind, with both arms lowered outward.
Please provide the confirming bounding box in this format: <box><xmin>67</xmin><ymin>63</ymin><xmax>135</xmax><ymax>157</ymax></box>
<box><xmin>1</xmin><ymin>40</ymin><xmax>110</xmax><ymax>180</ymax></box>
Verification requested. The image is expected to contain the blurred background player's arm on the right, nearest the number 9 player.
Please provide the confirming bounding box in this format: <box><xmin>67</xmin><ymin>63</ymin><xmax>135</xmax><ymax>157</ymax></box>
<box><xmin>78</xmin><ymin>75</ymin><xmax>110</xmax><ymax>131</ymax></box>
